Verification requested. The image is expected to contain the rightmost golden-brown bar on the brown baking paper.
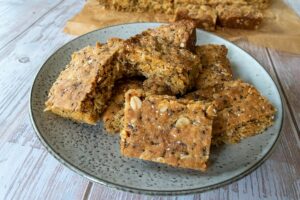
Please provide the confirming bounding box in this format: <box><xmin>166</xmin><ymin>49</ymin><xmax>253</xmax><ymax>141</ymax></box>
<box><xmin>216</xmin><ymin>5</ymin><xmax>263</xmax><ymax>29</ymax></box>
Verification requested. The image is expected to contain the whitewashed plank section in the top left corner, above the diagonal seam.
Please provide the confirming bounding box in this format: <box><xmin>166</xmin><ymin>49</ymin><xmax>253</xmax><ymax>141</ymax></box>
<box><xmin>0</xmin><ymin>0</ymin><xmax>63</xmax><ymax>48</ymax></box>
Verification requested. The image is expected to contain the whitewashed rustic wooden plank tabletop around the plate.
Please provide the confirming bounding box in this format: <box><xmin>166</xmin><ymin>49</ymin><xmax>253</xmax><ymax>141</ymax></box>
<box><xmin>0</xmin><ymin>0</ymin><xmax>300</xmax><ymax>200</ymax></box>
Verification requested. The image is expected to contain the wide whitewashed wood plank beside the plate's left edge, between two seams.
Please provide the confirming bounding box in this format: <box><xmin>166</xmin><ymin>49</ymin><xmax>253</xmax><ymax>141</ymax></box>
<box><xmin>0</xmin><ymin>0</ymin><xmax>89</xmax><ymax>199</ymax></box>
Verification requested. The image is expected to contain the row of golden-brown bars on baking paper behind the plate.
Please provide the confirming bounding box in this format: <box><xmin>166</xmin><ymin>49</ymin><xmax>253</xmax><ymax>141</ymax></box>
<box><xmin>98</xmin><ymin>0</ymin><xmax>270</xmax><ymax>31</ymax></box>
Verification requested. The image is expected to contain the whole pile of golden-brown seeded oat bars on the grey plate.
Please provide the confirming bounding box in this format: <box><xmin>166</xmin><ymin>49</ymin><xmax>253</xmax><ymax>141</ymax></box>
<box><xmin>45</xmin><ymin>21</ymin><xmax>276</xmax><ymax>171</ymax></box>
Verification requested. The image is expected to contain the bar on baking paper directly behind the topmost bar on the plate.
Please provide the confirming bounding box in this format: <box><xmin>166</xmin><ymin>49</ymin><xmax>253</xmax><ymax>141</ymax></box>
<box><xmin>174</xmin><ymin>4</ymin><xmax>217</xmax><ymax>31</ymax></box>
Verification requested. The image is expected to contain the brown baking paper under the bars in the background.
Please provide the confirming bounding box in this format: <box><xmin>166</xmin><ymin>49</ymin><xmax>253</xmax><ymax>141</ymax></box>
<box><xmin>64</xmin><ymin>0</ymin><xmax>300</xmax><ymax>54</ymax></box>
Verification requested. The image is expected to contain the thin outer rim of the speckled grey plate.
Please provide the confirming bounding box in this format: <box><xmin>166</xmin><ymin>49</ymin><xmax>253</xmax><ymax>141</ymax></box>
<box><xmin>29</xmin><ymin>22</ymin><xmax>285</xmax><ymax>196</ymax></box>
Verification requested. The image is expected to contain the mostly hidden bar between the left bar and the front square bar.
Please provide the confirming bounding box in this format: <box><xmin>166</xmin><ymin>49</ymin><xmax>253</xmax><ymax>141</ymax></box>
<box><xmin>102</xmin><ymin>79</ymin><xmax>143</xmax><ymax>133</ymax></box>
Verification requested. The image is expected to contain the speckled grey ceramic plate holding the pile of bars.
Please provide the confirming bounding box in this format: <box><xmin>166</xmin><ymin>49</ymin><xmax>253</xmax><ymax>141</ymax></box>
<box><xmin>30</xmin><ymin>23</ymin><xmax>283</xmax><ymax>195</ymax></box>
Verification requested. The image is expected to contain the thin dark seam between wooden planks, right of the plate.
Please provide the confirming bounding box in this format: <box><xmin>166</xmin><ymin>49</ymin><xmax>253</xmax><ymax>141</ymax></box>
<box><xmin>266</xmin><ymin>48</ymin><xmax>300</xmax><ymax>137</ymax></box>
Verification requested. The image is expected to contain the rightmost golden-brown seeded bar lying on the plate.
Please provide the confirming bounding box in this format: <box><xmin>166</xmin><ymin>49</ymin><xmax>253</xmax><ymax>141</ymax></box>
<box><xmin>186</xmin><ymin>80</ymin><xmax>276</xmax><ymax>144</ymax></box>
